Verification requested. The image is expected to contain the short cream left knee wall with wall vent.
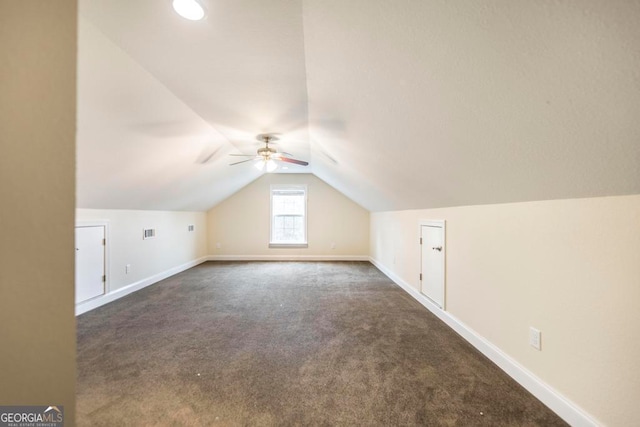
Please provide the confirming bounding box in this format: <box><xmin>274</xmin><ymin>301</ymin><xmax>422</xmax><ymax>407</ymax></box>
<box><xmin>76</xmin><ymin>209</ymin><xmax>207</xmax><ymax>291</ymax></box>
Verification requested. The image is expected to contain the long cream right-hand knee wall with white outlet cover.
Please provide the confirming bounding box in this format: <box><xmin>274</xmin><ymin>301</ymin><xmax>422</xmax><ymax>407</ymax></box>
<box><xmin>371</xmin><ymin>195</ymin><xmax>640</xmax><ymax>426</ymax></box>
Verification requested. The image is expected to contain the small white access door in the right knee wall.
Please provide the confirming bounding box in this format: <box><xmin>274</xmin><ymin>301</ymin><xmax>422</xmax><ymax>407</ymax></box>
<box><xmin>420</xmin><ymin>221</ymin><xmax>445</xmax><ymax>308</ymax></box>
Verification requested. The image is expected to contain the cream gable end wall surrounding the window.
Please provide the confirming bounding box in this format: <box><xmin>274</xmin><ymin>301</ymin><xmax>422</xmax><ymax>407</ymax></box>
<box><xmin>207</xmin><ymin>174</ymin><xmax>369</xmax><ymax>259</ymax></box>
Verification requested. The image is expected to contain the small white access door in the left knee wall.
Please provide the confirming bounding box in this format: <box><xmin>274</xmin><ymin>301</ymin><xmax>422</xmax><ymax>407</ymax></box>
<box><xmin>76</xmin><ymin>226</ymin><xmax>106</xmax><ymax>304</ymax></box>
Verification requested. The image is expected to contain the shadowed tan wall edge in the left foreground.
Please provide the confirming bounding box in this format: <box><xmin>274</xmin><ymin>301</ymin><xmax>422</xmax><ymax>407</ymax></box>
<box><xmin>0</xmin><ymin>0</ymin><xmax>77</xmax><ymax>425</ymax></box>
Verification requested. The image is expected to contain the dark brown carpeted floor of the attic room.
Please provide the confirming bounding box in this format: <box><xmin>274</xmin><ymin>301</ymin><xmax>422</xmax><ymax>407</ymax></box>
<box><xmin>77</xmin><ymin>262</ymin><xmax>565</xmax><ymax>426</ymax></box>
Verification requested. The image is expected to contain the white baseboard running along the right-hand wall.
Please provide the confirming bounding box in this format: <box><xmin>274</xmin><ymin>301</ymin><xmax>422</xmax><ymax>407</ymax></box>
<box><xmin>369</xmin><ymin>257</ymin><xmax>601</xmax><ymax>427</ymax></box>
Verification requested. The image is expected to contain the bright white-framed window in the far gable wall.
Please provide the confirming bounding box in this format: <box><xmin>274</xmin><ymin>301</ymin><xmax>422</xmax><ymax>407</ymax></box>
<box><xmin>269</xmin><ymin>185</ymin><xmax>307</xmax><ymax>248</ymax></box>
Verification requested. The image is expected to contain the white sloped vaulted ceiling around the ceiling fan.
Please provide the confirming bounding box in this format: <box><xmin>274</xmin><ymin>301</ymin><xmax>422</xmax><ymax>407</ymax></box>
<box><xmin>78</xmin><ymin>0</ymin><xmax>640</xmax><ymax>211</ymax></box>
